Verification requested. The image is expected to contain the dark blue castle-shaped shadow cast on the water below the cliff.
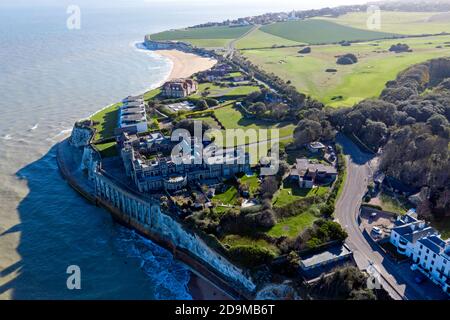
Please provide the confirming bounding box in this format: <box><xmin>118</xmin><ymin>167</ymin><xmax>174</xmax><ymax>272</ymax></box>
<box><xmin>0</xmin><ymin>147</ymin><xmax>190</xmax><ymax>299</ymax></box>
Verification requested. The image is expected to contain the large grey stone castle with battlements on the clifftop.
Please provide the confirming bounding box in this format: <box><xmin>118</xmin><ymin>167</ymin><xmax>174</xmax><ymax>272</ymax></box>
<box><xmin>119</xmin><ymin>133</ymin><xmax>250</xmax><ymax>192</ymax></box>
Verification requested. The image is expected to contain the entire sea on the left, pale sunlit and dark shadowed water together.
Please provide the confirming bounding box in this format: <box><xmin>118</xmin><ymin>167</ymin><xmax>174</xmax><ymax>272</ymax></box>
<box><xmin>0</xmin><ymin>0</ymin><xmax>298</xmax><ymax>299</ymax></box>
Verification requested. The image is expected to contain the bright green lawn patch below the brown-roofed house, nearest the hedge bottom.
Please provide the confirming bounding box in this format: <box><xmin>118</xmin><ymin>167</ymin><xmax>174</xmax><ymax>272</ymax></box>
<box><xmin>267</xmin><ymin>212</ymin><xmax>317</xmax><ymax>238</ymax></box>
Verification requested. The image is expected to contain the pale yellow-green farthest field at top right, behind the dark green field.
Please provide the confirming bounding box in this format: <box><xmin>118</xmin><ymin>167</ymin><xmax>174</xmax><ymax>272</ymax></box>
<box><xmin>320</xmin><ymin>11</ymin><xmax>450</xmax><ymax>35</ymax></box>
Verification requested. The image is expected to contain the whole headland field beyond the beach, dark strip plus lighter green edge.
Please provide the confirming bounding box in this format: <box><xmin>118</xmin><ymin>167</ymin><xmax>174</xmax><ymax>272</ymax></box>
<box><xmin>150</xmin><ymin>26</ymin><xmax>252</xmax><ymax>47</ymax></box>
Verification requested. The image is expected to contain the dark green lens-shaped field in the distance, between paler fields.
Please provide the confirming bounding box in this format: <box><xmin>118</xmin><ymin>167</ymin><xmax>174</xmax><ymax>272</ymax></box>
<box><xmin>260</xmin><ymin>19</ymin><xmax>394</xmax><ymax>44</ymax></box>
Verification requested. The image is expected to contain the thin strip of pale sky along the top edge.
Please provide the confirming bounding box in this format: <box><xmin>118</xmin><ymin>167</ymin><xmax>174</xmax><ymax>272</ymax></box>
<box><xmin>0</xmin><ymin>0</ymin><xmax>367</xmax><ymax>11</ymax></box>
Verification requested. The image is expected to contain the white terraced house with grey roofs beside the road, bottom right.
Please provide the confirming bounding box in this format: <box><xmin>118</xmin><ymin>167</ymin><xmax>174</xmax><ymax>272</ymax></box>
<box><xmin>390</xmin><ymin>210</ymin><xmax>450</xmax><ymax>294</ymax></box>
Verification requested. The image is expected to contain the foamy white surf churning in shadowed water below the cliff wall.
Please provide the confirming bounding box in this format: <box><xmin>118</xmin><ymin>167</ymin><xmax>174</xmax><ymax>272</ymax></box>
<box><xmin>117</xmin><ymin>227</ymin><xmax>192</xmax><ymax>300</ymax></box>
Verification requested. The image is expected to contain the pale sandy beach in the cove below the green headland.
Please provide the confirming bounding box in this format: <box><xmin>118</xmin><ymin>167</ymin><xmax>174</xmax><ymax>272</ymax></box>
<box><xmin>155</xmin><ymin>50</ymin><xmax>217</xmax><ymax>80</ymax></box>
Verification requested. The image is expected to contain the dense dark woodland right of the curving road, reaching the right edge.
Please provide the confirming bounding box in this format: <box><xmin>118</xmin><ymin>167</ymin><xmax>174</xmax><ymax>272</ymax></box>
<box><xmin>328</xmin><ymin>59</ymin><xmax>450</xmax><ymax>217</ymax></box>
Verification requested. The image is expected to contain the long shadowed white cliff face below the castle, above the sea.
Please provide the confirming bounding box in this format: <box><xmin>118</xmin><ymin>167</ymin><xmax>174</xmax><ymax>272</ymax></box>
<box><xmin>76</xmin><ymin>126</ymin><xmax>256</xmax><ymax>292</ymax></box>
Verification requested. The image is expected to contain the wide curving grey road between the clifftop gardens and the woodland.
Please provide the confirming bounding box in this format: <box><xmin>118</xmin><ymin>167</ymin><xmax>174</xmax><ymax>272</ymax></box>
<box><xmin>335</xmin><ymin>135</ymin><xmax>440</xmax><ymax>300</ymax></box>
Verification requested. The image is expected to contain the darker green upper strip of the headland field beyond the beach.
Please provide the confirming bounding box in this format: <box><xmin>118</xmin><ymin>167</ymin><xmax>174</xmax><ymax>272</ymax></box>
<box><xmin>150</xmin><ymin>26</ymin><xmax>252</xmax><ymax>41</ymax></box>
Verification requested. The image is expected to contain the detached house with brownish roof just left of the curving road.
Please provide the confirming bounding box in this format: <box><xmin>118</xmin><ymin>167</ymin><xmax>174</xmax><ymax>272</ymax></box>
<box><xmin>290</xmin><ymin>158</ymin><xmax>337</xmax><ymax>189</ymax></box>
